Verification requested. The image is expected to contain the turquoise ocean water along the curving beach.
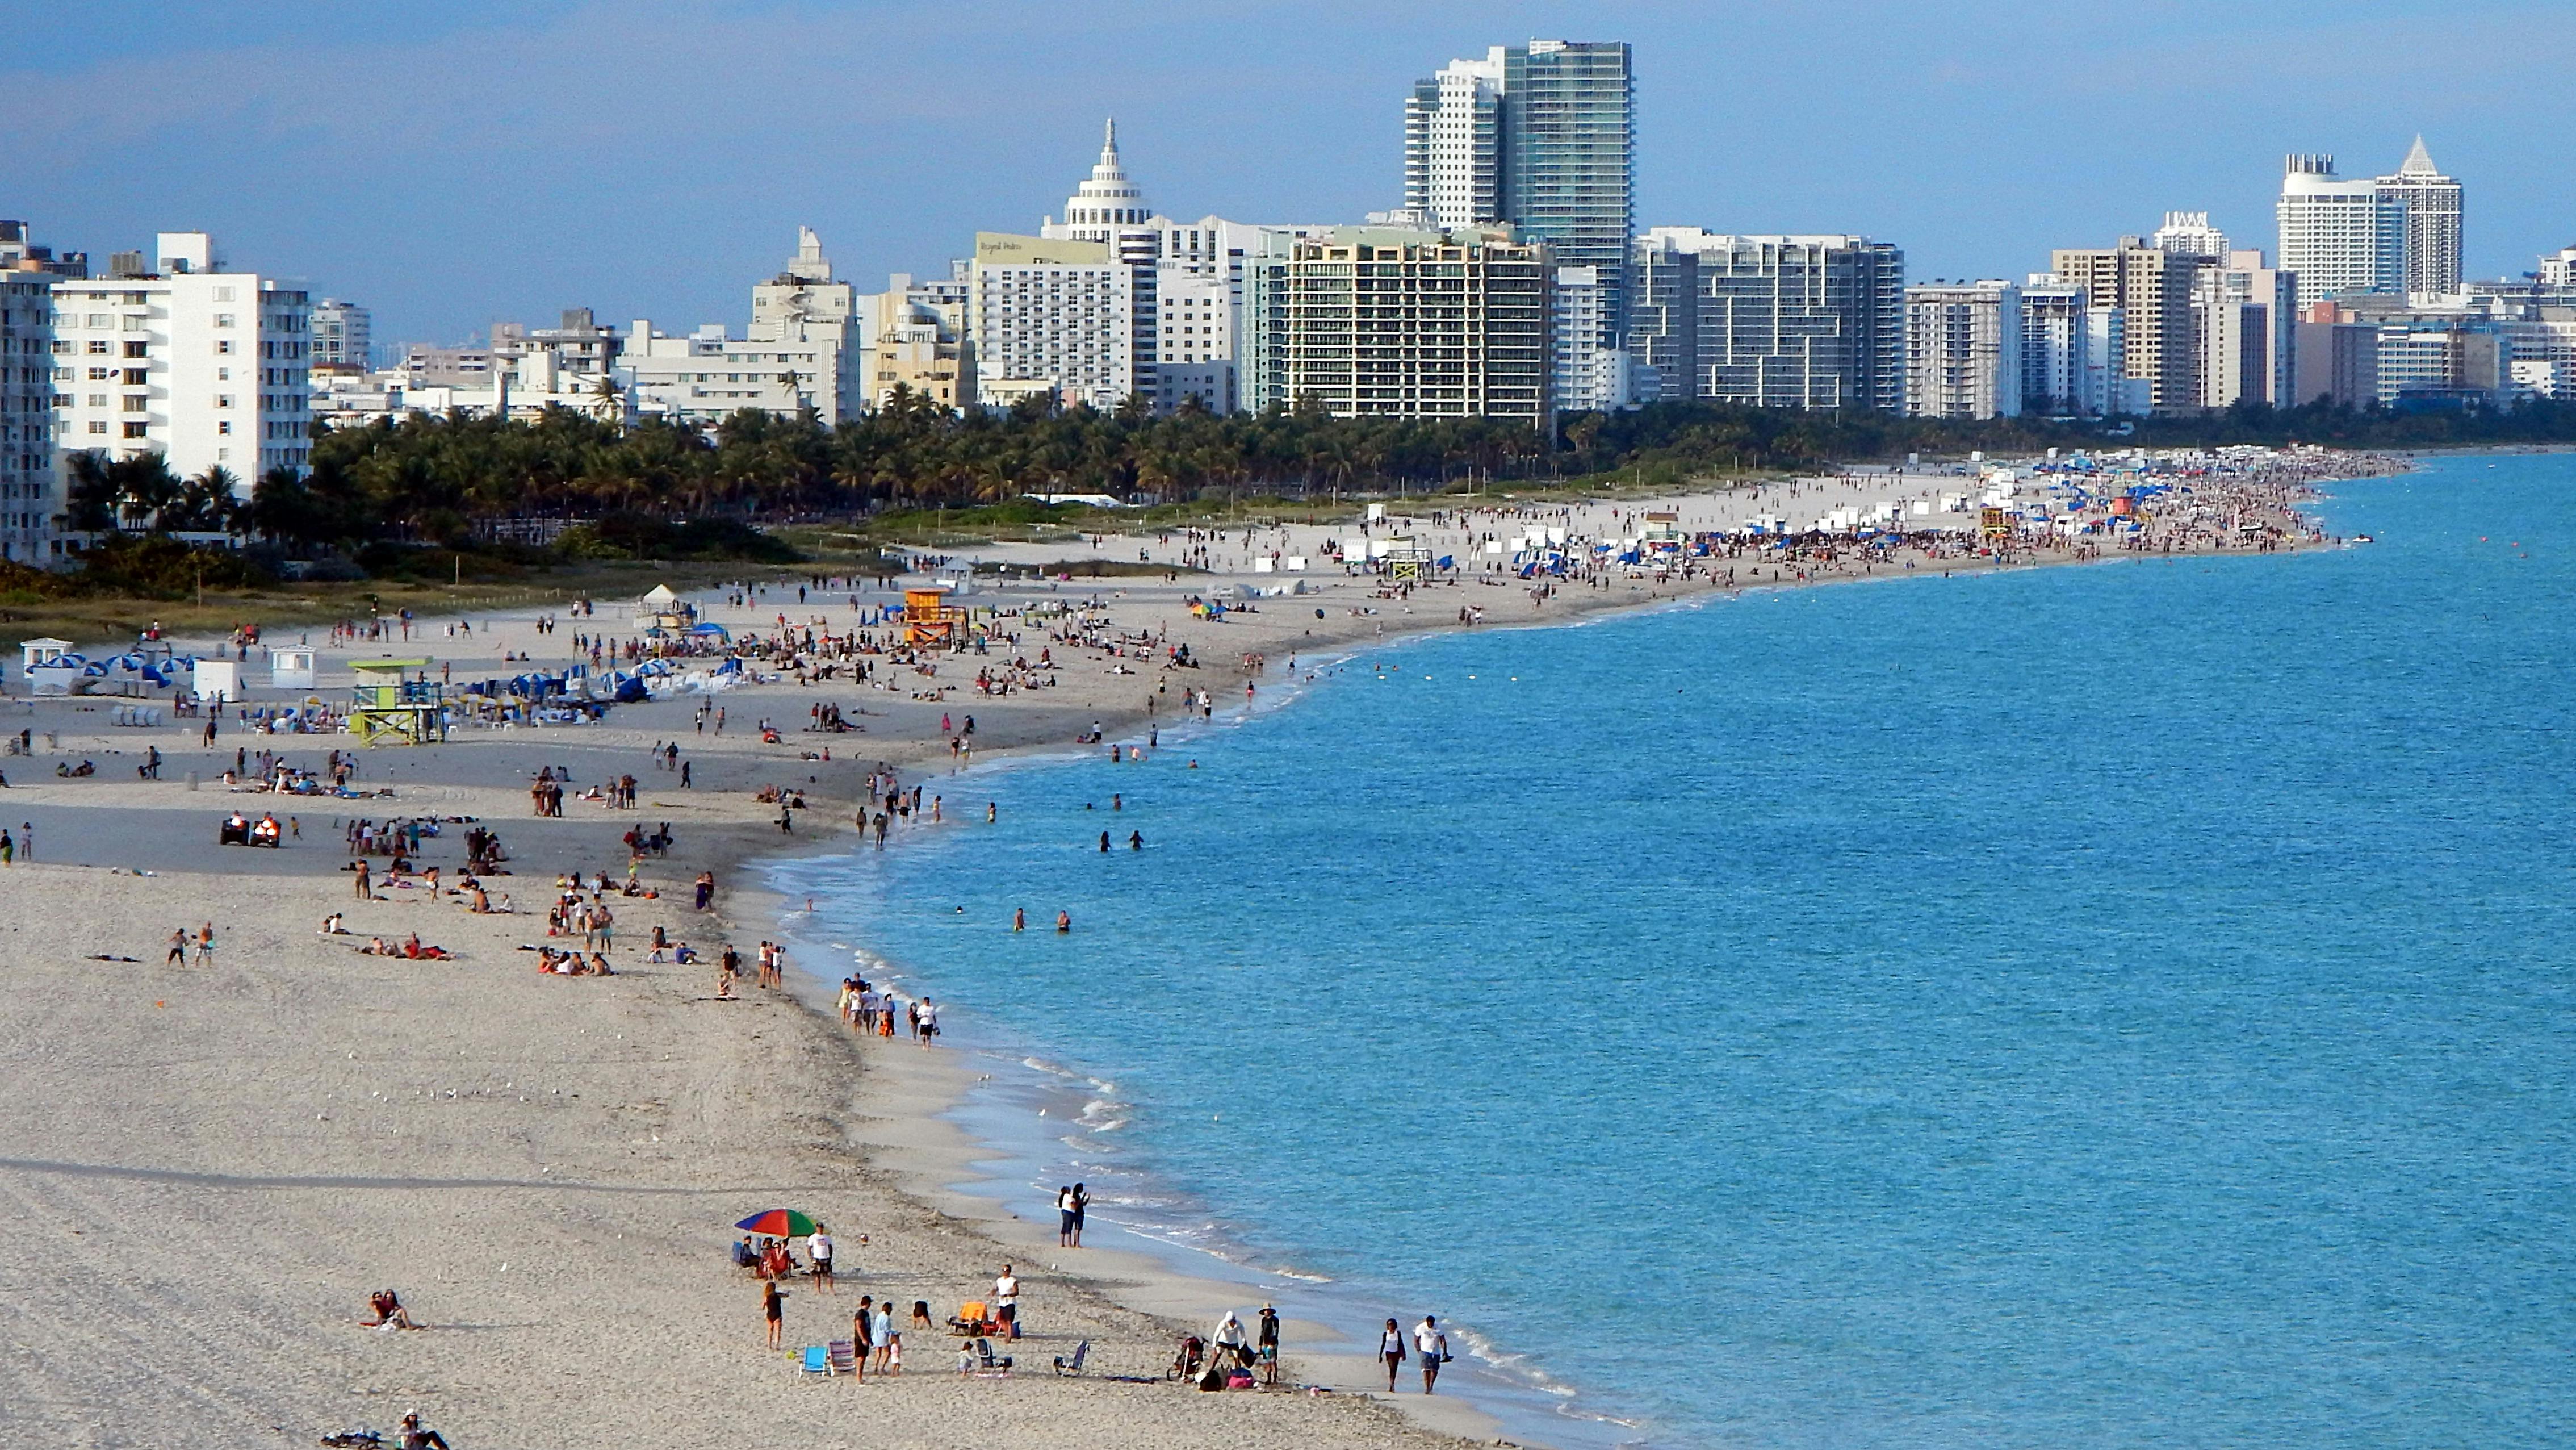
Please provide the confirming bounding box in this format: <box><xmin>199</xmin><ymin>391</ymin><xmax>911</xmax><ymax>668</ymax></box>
<box><xmin>781</xmin><ymin>456</ymin><xmax>2576</xmax><ymax>1447</ymax></box>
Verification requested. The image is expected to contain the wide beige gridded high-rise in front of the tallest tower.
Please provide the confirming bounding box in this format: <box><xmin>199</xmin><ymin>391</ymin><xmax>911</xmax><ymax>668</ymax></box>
<box><xmin>1244</xmin><ymin>227</ymin><xmax>1556</xmax><ymax>430</ymax></box>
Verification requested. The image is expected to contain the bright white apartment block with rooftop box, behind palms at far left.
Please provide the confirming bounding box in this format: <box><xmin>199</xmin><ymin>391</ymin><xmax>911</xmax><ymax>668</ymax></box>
<box><xmin>54</xmin><ymin>232</ymin><xmax>312</xmax><ymax>495</ymax></box>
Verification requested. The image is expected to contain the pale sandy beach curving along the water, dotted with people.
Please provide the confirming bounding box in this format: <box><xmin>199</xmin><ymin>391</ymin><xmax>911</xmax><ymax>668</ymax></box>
<box><xmin>0</xmin><ymin>463</ymin><xmax>2359</xmax><ymax>1450</ymax></box>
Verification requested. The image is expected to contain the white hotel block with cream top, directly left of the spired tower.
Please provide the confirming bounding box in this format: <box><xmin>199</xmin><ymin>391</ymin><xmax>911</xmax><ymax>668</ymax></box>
<box><xmin>969</xmin><ymin>232</ymin><xmax>1133</xmax><ymax>409</ymax></box>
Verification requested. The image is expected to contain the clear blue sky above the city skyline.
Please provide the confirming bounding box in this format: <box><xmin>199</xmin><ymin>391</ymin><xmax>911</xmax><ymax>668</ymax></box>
<box><xmin>0</xmin><ymin>0</ymin><xmax>2576</xmax><ymax>353</ymax></box>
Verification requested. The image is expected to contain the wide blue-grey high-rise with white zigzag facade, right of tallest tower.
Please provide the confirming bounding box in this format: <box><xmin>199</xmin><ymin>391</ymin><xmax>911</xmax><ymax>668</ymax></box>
<box><xmin>1628</xmin><ymin>227</ymin><xmax>1906</xmax><ymax>412</ymax></box>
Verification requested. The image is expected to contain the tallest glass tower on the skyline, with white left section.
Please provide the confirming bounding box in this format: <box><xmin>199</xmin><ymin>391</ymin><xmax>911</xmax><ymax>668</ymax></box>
<box><xmin>1404</xmin><ymin>41</ymin><xmax>1636</xmax><ymax>345</ymax></box>
